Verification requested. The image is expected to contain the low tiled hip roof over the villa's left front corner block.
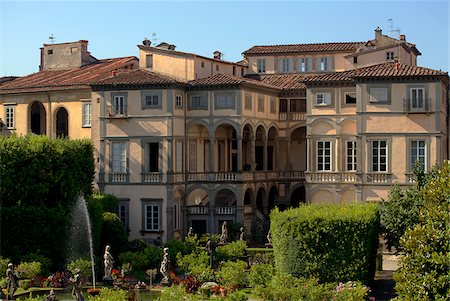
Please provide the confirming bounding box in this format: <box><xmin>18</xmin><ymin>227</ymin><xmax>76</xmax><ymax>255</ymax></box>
<box><xmin>92</xmin><ymin>69</ymin><xmax>181</xmax><ymax>86</ymax></box>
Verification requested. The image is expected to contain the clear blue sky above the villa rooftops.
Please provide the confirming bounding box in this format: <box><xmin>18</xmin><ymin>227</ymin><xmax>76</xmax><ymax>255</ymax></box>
<box><xmin>0</xmin><ymin>0</ymin><xmax>450</xmax><ymax>76</ymax></box>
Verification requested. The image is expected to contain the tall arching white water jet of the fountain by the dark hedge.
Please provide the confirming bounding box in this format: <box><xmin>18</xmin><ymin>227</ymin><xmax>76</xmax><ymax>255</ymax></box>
<box><xmin>69</xmin><ymin>194</ymin><xmax>95</xmax><ymax>290</ymax></box>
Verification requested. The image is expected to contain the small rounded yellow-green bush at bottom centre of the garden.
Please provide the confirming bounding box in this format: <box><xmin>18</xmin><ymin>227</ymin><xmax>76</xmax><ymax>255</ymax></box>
<box><xmin>216</xmin><ymin>260</ymin><xmax>248</xmax><ymax>288</ymax></box>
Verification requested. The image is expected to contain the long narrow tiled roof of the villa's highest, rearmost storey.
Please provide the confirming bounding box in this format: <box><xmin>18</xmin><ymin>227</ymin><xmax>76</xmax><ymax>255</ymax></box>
<box><xmin>243</xmin><ymin>42</ymin><xmax>364</xmax><ymax>54</ymax></box>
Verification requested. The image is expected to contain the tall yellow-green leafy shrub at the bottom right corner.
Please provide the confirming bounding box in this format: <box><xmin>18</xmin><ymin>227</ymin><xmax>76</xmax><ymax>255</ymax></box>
<box><xmin>394</xmin><ymin>161</ymin><xmax>450</xmax><ymax>301</ymax></box>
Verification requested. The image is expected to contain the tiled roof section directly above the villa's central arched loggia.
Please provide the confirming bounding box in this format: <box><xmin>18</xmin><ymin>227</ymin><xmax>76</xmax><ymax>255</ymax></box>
<box><xmin>189</xmin><ymin>74</ymin><xmax>279</xmax><ymax>90</ymax></box>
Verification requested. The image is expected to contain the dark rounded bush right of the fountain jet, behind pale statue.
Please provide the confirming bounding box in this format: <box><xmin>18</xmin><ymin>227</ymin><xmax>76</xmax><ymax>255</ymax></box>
<box><xmin>100</xmin><ymin>212</ymin><xmax>128</xmax><ymax>258</ymax></box>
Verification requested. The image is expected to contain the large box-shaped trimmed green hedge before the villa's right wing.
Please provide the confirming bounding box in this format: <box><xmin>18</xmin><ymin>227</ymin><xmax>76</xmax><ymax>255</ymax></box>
<box><xmin>270</xmin><ymin>203</ymin><xmax>380</xmax><ymax>282</ymax></box>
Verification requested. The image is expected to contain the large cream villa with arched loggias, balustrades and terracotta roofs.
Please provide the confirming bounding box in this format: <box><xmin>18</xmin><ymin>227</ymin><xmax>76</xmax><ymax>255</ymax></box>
<box><xmin>0</xmin><ymin>28</ymin><xmax>449</xmax><ymax>241</ymax></box>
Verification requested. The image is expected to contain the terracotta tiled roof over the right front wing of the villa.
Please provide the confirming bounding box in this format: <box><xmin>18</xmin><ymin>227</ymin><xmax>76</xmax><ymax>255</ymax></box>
<box><xmin>304</xmin><ymin>62</ymin><xmax>448</xmax><ymax>84</ymax></box>
